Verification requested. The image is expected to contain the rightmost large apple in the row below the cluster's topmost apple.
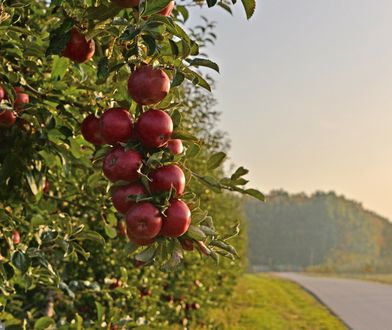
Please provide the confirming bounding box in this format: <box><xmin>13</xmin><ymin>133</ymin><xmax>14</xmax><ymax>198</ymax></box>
<box><xmin>135</xmin><ymin>110</ymin><xmax>173</xmax><ymax>148</ymax></box>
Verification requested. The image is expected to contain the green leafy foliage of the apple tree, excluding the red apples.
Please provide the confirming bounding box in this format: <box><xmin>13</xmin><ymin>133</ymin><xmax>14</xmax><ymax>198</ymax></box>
<box><xmin>0</xmin><ymin>0</ymin><xmax>263</xmax><ymax>329</ymax></box>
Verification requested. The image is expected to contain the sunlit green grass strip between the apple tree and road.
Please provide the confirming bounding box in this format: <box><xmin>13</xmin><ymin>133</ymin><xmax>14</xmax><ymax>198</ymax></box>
<box><xmin>210</xmin><ymin>275</ymin><xmax>346</xmax><ymax>330</ymax></box>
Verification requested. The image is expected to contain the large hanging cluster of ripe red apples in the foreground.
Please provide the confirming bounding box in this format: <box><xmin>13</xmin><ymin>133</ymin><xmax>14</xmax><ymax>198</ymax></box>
<box><xmin>81</xmin><ymin>65</ymin><xmax>191</xmax><ymax>245</ymax></box>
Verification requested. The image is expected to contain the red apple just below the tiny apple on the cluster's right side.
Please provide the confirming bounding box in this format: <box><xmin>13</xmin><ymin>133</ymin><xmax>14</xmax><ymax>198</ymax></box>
<box><xmin>150</xmin><ymin>165</ymin><xmax>185</xmax><ymax>195</ymax></box>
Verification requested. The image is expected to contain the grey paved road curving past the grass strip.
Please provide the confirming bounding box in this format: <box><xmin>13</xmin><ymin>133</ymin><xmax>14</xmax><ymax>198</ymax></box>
<box><xmin>276</xmin><ymin>273</ymin><xmax>392</xmax><ymax>330</ymax></box>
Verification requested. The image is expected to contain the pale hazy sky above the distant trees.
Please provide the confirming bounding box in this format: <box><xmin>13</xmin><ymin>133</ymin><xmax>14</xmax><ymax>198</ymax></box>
<box><xmin>188</xmin><ymin>0</ymin><xmax>392</xmax><ymax>219</ymax></box>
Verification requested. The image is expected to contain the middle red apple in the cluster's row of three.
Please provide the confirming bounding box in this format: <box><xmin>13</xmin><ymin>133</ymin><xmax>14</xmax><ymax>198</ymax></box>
<box><xmin>101</xmin><ymin>108</ymin><xmax>133</xmax><ymax>144</ymax></box>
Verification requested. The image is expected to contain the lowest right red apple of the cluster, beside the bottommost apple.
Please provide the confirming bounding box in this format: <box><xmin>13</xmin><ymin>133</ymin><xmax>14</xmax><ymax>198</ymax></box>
<box><xmin>160</xmin><ymin>199</ymin><xmax>193</xmax><ymax>237</ymax></box>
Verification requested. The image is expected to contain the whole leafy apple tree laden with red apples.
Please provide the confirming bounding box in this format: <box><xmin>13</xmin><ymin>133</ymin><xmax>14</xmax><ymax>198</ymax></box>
<box><xmin>0</xmin><ymin>0</ymin><xmax>264</xmax><ymax>329</ymax></box>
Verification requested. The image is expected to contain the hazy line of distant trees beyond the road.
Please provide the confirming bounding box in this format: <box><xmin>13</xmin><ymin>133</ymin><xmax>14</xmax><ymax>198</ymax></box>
<box><xmin>245</xmin><ymin>191</ymin><xmax>392</xmax><ymax>272</ymax></box>
